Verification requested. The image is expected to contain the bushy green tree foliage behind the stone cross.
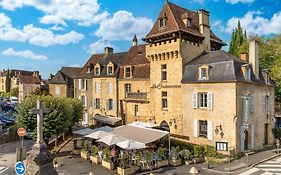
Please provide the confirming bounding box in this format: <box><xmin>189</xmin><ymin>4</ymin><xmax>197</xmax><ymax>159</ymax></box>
<box><xmin>17</xmin><ymin>95</ymin><xmax>83</xmax><ymax>143</ymax></box>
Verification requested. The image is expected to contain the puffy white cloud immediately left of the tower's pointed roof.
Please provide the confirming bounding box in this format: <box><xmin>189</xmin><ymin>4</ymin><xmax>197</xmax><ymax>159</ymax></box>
<box><xmin>95</xmin><ymin>10</ymin><xmax>153</xmax><ymax>41</ymax></box>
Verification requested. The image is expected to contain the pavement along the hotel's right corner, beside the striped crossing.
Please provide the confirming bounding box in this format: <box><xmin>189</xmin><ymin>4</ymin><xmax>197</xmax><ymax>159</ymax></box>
<box><xmin>207</xmin><ymin>149</ymin><xmax>280</xmax><ymax>174</ymax></box>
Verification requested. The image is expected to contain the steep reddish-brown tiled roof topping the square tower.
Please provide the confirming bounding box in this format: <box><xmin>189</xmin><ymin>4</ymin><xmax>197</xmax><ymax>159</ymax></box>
<box><xmin>144</xmin><ymin>1</ymin><xmax>225</xmax><ymax>45</ymax></box>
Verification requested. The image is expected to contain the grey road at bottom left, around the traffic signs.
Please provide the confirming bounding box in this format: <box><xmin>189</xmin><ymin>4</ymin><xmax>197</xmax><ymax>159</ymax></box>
<box><xmin>0</xmin><ymin>140</ymin><xmax>34</xmax><ymax>175</ymax></box>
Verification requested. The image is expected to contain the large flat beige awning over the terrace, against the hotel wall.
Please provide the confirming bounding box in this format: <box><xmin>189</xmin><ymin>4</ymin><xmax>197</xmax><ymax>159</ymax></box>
<box><xmin>112</xmin><ymin>125</ymin><xmax>169</xmax><ymax>144</ymax></box>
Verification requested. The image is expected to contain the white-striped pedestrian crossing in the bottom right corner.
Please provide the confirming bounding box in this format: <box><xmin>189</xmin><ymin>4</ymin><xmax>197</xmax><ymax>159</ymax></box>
<box><xmin>239</xmin><ymin>157</ymin><xmax>281</xmax><ymax>175</ymax></box>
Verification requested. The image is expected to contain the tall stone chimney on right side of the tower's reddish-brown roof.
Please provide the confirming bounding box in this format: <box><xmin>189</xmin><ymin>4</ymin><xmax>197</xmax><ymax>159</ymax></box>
<box><xmin>198</xmin><ymin>9</ymin><xmax>211</xmax><ymax>52</ymax></box>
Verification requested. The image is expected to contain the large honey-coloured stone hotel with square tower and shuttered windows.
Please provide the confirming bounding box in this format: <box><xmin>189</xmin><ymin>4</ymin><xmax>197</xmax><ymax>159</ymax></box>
<box><xmin>74</xmin><ymin>1</ymin><xmax>274</xmax><ymax>153</ymax></box>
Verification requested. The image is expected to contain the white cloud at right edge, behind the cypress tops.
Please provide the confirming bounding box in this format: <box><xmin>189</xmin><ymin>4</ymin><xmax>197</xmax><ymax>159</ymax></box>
<box><xmin>226</xmin><ymin>11</ymin><xmax>281</xmax><ymax>35</ymax></box>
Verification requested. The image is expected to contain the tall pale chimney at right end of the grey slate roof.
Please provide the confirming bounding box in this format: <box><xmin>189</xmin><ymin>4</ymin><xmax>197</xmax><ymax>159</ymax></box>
<box><xmin>249</xmin><ymin>40</ymin><xmax>259</xmax><ymax>79</ymax></box>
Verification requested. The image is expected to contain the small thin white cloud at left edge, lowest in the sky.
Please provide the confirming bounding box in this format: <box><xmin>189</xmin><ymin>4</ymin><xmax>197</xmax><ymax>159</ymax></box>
<box><xmin>1</xmin><ymin>48</ymin><xmax>48</xmax><ymax>60</ymax></box>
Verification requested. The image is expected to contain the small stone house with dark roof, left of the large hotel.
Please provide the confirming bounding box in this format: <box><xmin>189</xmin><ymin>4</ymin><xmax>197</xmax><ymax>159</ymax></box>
<box><xmin>49</xmin><ymin>67</ymin><xmax>81</xmax><ymax>98</ymax></box>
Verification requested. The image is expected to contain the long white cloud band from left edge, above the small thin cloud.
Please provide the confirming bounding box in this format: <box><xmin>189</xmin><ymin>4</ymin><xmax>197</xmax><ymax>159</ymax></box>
<box><xmin>0</xmin><ymin>13</ymin><xmax>84</xmax><ymax>47</ymax></box>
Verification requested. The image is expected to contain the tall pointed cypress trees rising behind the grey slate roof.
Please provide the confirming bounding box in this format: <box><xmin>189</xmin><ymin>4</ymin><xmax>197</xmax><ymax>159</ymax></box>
<box><xmin>228</xmin><ymin>20</ymin><xmax>248</xmax><ymax>57</ymax></box>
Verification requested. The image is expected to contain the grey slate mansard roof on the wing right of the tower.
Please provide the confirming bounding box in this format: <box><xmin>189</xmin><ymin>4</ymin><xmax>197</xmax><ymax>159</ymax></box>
<box><xmin>182</xmin><ymin>50</ymin><xmax>274</xmax><ymax>85</ymax></box>
